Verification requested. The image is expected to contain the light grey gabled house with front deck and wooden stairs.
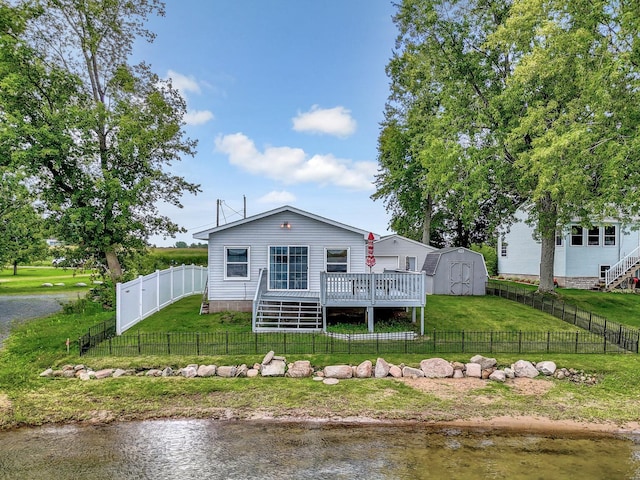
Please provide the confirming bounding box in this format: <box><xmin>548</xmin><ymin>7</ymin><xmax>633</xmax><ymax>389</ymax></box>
<box><xmin>194</xmin><ymin>206</ymin><xmax>426</xmax><ymax>331</ymax></box>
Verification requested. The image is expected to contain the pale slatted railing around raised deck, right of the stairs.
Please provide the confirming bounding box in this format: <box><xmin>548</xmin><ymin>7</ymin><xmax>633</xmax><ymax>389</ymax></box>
<box><xmin>320</xmin><ymin>272</ymin><xmax>426</xmax><ymax>306</ymax></box>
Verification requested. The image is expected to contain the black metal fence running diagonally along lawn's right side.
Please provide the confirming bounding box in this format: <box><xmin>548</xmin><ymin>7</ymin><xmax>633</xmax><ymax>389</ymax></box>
<box><xmin>487</xmin><ymin>281</ymin><xmax>640</xmax><ymax>353</ymax></box>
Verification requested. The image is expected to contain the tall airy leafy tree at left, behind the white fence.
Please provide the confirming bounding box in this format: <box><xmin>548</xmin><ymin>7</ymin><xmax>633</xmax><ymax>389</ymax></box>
<box><xmin>0</xmin><ymin>0</ymin><xmax>198</xmax><ymax>279</ymax></box>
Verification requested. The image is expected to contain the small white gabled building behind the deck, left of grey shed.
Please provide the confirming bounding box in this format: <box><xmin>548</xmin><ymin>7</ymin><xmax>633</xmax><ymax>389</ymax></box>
<box><xmin>373</xmin><ymin>234</ymin><xmax>437</xmax><ymax>273</ymax></box>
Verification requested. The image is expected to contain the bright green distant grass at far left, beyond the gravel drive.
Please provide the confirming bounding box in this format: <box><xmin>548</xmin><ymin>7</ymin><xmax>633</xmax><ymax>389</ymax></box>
<box><xmin>0</xmin><ymin>266</ymin><xmax>94</xmax><ymax>295</ymax></box>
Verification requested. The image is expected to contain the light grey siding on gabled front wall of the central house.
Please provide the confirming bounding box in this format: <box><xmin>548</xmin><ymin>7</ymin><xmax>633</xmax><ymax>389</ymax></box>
<box><xmin>209</xmin><ymin>211</ymin><xmax>368</xmax><ymax>301</ymax></box>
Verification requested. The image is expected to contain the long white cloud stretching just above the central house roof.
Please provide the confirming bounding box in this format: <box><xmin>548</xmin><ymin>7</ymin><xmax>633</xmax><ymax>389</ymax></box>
<box><xmin>215</xmin><ymin>133</ymin><xmax>378</xmax><ymax>190</ymax></box>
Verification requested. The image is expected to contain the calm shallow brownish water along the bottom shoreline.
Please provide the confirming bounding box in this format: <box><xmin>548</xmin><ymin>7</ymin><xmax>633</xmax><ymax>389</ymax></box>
<box><xmin>0</xmin><ymin>420</ymin><xmax>640</xmax><ymax>480</ymax></box>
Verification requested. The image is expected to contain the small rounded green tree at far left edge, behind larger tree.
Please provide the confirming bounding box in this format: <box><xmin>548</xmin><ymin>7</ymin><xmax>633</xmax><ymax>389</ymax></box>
<box><xmin>0</xmin><ymin>167</ymin><xmax>48</xmax><ymax>275</ymax></box>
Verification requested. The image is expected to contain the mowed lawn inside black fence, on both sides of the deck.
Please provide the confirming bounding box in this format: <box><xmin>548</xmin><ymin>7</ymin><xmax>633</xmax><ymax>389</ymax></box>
<box><xmin>131</xmin><ymin>295</ymin><xmax>596</xmax><ymax>334</ymax></box>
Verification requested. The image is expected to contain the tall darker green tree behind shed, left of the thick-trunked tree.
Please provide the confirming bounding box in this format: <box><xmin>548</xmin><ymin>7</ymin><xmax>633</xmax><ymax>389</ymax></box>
<box><xmin>373</xmin><ymin>0</ymin><xmax>515</xmax><ymax>247</ymax></box>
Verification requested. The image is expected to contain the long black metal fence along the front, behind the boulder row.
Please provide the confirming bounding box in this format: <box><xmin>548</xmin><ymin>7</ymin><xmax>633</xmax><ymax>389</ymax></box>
<box><xmin>81</xmin><ymin>330</ymin><xmax>624</xmax><ymax>356</ymax></box>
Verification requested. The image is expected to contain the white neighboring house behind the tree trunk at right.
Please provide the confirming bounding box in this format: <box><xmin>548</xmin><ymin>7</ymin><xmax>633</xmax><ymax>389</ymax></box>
<box><xmin>498</xmin><ymin>212</ymin><xmax>640</xmax><ymax>289</ymax></box>
